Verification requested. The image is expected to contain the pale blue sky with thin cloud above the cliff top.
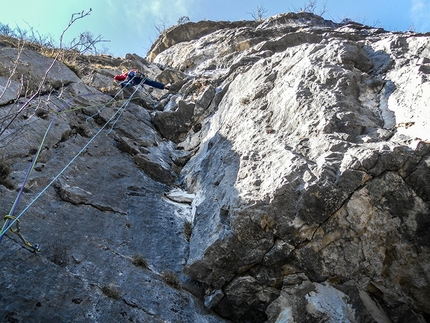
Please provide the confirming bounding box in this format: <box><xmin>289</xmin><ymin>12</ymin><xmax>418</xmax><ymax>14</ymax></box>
<box><xmin>0</xmin><ymin>0</ymin><xmax>430</xmax><ymax>57</ymax></box>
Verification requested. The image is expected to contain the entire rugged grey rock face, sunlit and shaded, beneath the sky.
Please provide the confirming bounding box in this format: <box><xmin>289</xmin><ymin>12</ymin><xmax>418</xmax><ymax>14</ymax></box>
<box><xmin>0</xmin><ymin>13</ymin><xmax>430</xmax><ymax>323</ymax></box>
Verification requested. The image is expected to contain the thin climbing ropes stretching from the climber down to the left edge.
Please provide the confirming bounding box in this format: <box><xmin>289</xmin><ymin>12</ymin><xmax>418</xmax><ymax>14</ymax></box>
<box><xmin>0</xmin><ymin>82</ymin><xmax>143</xmax><ymax>251</ymax></box>
